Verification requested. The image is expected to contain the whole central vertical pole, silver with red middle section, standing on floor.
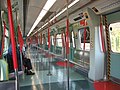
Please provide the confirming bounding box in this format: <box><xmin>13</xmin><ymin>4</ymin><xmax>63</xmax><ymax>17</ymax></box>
<box><xmin>66</xmin><ymin>0</ymin><xmax>69</xmax><ymax>90</ymax></box>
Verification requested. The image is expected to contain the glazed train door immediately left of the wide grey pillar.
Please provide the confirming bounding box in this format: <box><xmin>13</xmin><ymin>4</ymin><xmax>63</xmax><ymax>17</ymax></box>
<box><xmin>79</xmin><ymin>27</ymin><xmax>90</xmax><ymax>70</ymax></box>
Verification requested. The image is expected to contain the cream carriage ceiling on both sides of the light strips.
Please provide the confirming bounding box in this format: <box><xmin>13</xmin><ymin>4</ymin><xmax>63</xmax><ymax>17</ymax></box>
<box><xmin>0</xmin><ymin>0</ymin><xmax>91</xmax><ymax>36</ymax></box>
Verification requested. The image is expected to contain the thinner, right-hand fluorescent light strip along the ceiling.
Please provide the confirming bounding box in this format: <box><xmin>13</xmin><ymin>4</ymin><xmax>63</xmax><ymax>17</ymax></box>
<box><xmin>34</xmin><ymin>0</ymin><xmax>80</xmax><ymax>34</ymax></box>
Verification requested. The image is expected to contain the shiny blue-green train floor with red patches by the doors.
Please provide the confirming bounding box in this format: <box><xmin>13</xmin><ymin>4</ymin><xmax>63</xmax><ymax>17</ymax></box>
<box><xmin>19</xmin><ymin>49</ymin><xmax>120</xmax><ymax>90</ymax></box>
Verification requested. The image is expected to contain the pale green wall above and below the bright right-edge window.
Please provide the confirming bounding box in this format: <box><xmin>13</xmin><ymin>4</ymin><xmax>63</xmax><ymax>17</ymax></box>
<box><xmin>107</xmin><ymin>11</ymin><xmax>120</xmax><ymax>79</ymax></box>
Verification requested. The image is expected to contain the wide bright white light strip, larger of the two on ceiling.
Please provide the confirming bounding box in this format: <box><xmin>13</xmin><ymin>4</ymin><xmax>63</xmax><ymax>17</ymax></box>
<box><xmin>27</xmin><ymin>0</ymin><xmax>56</xmax><ymax>36</ymax></box>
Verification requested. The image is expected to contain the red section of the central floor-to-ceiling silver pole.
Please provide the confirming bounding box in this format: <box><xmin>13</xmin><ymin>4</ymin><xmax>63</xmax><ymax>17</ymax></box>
<box><xmin>66</xmin><ymin>19</ymin><xmax>69</xmax><ymax>54</ymax></box>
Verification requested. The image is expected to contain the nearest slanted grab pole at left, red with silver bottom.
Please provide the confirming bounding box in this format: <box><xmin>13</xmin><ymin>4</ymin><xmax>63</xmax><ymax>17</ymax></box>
<box><xmin>7</xmin><ymin>0</ymin><xmax>19</xmax><ymax>90</ymax></box>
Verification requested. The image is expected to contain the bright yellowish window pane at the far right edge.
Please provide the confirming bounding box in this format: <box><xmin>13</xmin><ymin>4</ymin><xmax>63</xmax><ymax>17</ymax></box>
<box><xmin>109</xmin><ymin>22</ymin><xmax>120</xmax><ymax>53</ymax></box>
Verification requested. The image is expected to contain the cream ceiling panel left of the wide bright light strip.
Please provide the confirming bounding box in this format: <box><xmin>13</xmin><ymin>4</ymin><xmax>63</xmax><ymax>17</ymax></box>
<box><xmin>25</xmin><ymin>0</ymin><xmax>47</xmax><ymax>35</ymax></box>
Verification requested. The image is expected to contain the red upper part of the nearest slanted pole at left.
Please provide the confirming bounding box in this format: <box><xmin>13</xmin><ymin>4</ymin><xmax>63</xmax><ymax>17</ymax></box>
<box><xmin>7</xmin><ymin>0</ymin><xmax>18</xmax><ymax>70</ymax></box>
